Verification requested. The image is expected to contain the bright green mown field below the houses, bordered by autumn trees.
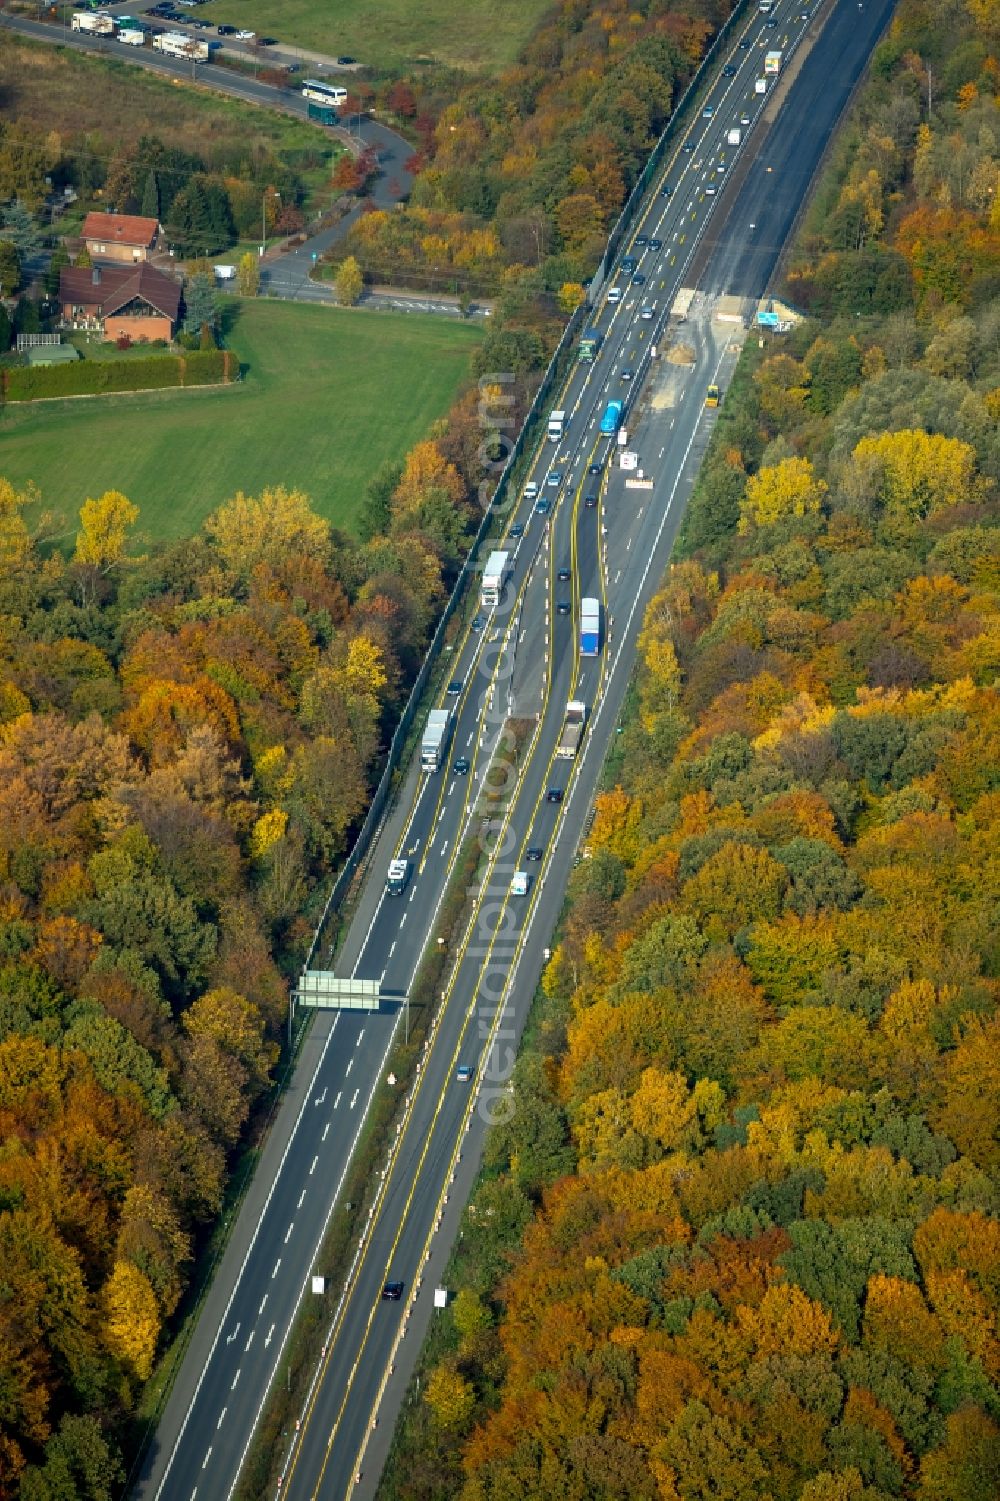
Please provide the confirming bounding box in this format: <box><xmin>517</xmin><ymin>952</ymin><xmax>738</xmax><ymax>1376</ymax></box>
<box><xmin>0</xmin><ymin>300</ymin><xmax>479</xmax><ymax>540</ymax></box>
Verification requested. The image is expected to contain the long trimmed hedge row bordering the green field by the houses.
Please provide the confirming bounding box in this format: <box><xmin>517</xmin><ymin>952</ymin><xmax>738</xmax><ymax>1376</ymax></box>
<box><xmin>0</xmin><ymin>350</ymin><xmax>239</xmax><ymax>401</ymax></box>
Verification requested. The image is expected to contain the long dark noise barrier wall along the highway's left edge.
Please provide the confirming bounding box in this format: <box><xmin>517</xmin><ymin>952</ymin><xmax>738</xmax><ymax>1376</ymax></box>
<box><xmin>302</xmin><ymin>0</ymin><xmax>755</xmax><ymax>970</ymax></box>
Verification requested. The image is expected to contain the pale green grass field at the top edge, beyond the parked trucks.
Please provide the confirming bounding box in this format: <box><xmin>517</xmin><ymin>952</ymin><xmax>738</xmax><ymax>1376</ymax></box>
<box><xmin>202</xmin><ymin>0</ymin><xmax>550</xmax><ymax>72</ymax></box>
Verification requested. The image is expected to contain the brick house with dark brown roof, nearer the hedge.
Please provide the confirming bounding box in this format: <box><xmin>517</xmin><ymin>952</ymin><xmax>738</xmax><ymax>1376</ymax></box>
<box><xmin>59</xmin><ymin>261</ymin><xmax>180</xmax><ymax>344</ymax></box>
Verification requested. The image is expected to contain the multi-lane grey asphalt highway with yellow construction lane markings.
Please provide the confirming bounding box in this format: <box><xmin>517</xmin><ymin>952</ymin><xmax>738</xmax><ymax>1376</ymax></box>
<box><xmin>124</xmin><ymin>0</ymin><xmax>890</xmax><ymax>1501</ymax></box>
